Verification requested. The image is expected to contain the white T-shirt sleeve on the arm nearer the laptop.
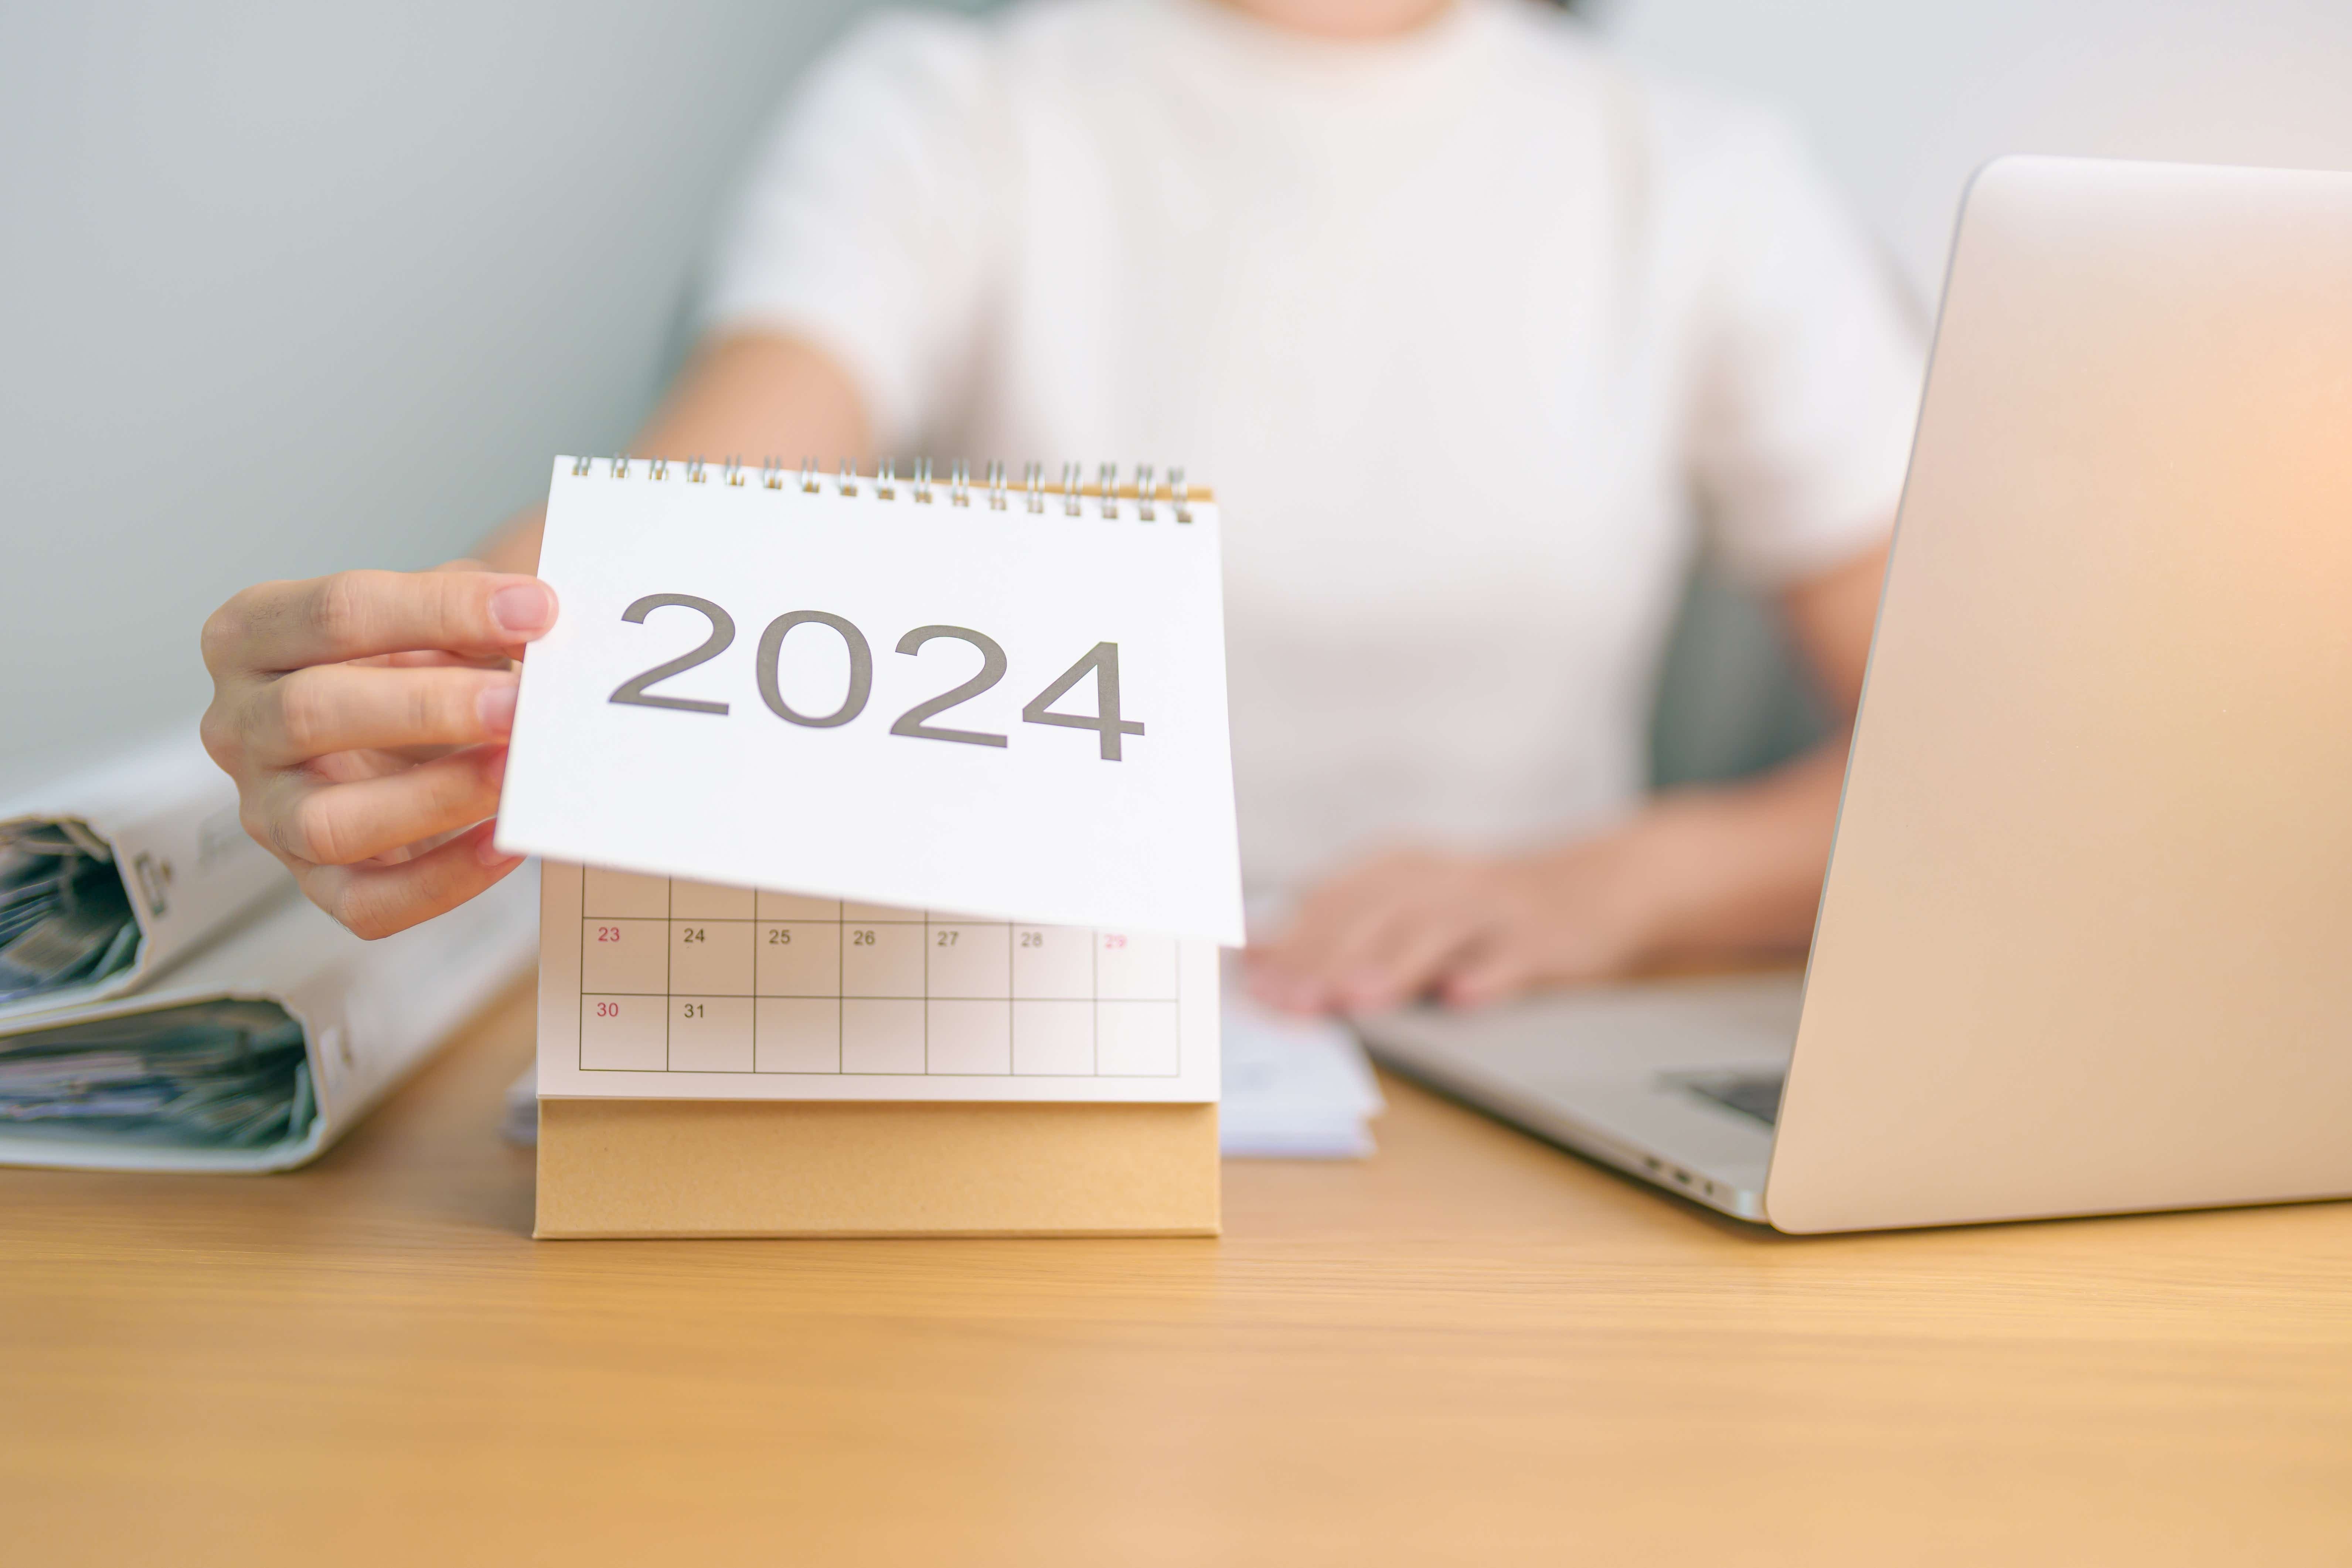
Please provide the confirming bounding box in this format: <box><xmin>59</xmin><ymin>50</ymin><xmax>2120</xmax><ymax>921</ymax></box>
<box><xmin>1689</xmin><ymin>118</ymin><xmax>1924</xmax><ymax>588</ymax></box>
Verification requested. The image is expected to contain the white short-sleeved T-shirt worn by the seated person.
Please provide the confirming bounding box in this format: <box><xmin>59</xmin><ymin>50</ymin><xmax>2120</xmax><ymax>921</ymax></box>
<box><xmin>706</xmin><ymin>0</ymin><xmax>1919</xmax><ymax>893</ymax></box>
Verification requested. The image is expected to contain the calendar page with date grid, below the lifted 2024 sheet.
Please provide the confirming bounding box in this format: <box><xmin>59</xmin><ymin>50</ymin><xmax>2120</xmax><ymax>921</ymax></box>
<box><xmin>539</xmin><ymin>863</ymin><xmax>1218</xmax><ymax>1102</ymax></box>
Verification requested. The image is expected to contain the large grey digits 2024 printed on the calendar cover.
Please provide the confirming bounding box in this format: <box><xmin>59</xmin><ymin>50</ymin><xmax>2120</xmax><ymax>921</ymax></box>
<box><xmin>609</xmin><ymin>592</ymin><xmax>1143</xmax><ymax>762</ymax></box>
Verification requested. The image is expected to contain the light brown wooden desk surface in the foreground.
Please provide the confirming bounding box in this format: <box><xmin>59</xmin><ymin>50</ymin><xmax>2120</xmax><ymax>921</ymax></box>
<box><xmin>14</xmin><ymin>990</ymin><xmax>2352</xmax><ymax>1568</ymax></box>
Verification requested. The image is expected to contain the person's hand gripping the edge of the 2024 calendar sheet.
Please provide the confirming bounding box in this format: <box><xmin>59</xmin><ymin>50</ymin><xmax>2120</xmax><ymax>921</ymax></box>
<box><xmin>202</xmin><ymin>562</ymin><xmax>555</xmax><ymax>938</ymax></box>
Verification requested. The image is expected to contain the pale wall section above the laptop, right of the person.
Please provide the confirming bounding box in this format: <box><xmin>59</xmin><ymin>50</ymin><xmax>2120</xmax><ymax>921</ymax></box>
<box><xmin>1590</xmin><ymin>0</ymin><xmax>2352</xmax><ymax>301</ymax></box>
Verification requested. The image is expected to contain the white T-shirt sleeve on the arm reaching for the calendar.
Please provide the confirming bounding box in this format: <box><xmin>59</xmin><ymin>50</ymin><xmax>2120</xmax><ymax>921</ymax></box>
<box><xmin>698</xmin><ymin>14</ymin><xmax>1002</xmax><ymax>447</ymax></box>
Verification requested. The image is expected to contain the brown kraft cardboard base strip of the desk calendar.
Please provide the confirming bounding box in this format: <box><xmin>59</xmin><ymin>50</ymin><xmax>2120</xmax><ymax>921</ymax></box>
<box><xmin>534</xmin><ymin>1100</ymin><xmax>1218</xmax><ymax>1239</ymax></box>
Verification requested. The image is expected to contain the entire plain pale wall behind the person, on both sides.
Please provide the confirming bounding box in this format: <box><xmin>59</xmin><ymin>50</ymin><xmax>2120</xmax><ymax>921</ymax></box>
<box><xmin>0</xmin><ymin>0</ymin><xmax>2352</xmax><ymax>773</ymax></box>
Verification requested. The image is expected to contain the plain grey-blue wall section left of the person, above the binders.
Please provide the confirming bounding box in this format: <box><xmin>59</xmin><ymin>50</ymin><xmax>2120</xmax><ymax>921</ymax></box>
<box><xmin>0</xmin><ymin>0</ymin><xmax>849</xmax><ymax>776</ymax></box>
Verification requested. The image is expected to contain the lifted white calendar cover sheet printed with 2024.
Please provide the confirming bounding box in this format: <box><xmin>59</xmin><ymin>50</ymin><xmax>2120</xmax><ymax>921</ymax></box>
<box><xmin>498</xmin><ymin>458</ymin><xmax>1242</xmax><ymax>945</ymax></box>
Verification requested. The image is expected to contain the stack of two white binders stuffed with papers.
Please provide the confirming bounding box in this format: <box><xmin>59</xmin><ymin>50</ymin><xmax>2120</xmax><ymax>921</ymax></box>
<box><xmin>0</xmin><ymin>738</ymin><xmax>536</xmax><ymax>1171</ymax></box>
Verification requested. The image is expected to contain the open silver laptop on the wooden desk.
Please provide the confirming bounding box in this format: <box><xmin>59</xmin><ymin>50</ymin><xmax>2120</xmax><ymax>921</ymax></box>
<box><xmin>1359</xmin><ymin>157</ymin><xmax>2352</xmax><ymax>1232</ymax></box>
